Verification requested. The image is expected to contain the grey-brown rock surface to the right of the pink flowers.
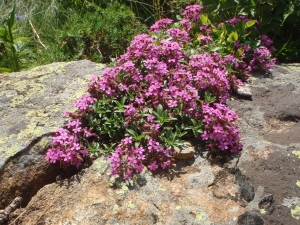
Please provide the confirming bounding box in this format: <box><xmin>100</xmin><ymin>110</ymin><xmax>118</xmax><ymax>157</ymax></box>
<box><xmin>229</xmin><ymin>64</ymin><xmax>300</xmax><ymax>225</ymax></box>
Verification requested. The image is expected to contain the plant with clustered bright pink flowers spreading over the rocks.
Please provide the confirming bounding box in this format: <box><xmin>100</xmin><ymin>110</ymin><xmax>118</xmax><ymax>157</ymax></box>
<box><xmin>47</xmin><ymin>5</ymin><xmax>276</xmax><ymax>179</ymax></box>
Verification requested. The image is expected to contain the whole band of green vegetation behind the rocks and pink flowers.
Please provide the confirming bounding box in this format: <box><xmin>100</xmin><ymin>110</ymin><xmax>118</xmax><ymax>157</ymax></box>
<box><xmin>0</xmin><ymin>0</ymin><xmax>300</xmax><ymax>71</ymax></box>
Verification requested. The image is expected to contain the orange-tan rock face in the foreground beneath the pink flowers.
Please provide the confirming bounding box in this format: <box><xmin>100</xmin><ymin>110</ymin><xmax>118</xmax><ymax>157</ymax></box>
<box><xmin>12</xmin><ymin>157</ymin><xmax>245</xmax><ymax>225</ymax></box>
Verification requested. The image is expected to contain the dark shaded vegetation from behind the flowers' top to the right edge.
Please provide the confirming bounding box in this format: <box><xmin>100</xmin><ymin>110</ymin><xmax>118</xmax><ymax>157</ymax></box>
<box><xmin>126</xmin><ymin>0</ymin><xmax>300</xmax><ymax>62</ymax></box>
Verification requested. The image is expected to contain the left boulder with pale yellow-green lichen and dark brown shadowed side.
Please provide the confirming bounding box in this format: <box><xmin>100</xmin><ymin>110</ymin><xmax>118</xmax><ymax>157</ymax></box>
<box><xmin>0</xmin><ymin>60</ymin><xmax>104</xmax><ymax>209</ymax></box>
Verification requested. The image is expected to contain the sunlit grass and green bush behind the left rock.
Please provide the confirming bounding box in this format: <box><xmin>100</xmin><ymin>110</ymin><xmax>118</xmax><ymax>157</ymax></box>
<box><xmin>0</xmin><ymin>0</ymin><xmax>146</xmax><ymax>68</ymax></box>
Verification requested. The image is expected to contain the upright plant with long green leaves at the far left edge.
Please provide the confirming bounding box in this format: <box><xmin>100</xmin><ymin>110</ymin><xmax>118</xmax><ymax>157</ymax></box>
<box><xmin>0</xmin><ymin>6</ymin><xmax>30</xmax><ymax>72</ymax></box>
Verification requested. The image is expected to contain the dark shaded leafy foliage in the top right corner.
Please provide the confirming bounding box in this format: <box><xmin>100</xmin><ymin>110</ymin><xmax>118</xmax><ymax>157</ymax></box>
<box><xmin>203</xmin><ymin>0</ymin><xmax>300</xmax><ymax>62</ymax></box>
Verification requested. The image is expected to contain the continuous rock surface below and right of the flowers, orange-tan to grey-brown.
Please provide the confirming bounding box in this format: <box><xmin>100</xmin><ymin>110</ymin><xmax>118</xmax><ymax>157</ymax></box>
<box><xmin>0</xmin><ymin>64</ymin><xmax>300</xmax><ymax>225</ymax></box>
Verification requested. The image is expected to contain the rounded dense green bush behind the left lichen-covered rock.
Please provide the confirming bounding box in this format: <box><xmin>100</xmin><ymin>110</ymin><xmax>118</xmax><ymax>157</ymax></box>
<box><xmin>45</xmin><ymin>2</ymin><xmax>145</xmax><ymax>63</ymax></box>
